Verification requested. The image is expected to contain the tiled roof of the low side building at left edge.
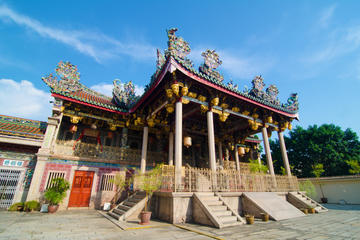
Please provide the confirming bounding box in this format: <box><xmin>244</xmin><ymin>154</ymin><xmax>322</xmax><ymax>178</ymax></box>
<box><xmin>0</xmin><ymin>115</ymin><xmax>47</xmax><ymax>139</ymax></box>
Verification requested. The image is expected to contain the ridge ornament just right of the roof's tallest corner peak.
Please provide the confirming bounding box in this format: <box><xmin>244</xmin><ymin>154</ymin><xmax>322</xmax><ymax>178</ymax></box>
<box><xmin>199</xmin><ymin>49</ymin><xmax>224</xmax><ymax>82</ymax></box>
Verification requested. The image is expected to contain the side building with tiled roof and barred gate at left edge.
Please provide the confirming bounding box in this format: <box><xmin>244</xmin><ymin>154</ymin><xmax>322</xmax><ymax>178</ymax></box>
<box><xmin>0</xmin><ymin>115</ymin><xmax>47</xmax><ymax>208</ymax></box>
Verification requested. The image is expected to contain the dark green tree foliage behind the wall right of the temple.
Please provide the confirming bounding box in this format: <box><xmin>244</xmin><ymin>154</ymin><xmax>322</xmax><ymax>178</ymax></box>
<box><xmin>270</xmin><ymin>124</ymin><xmax>360</xmax><ymax>177</ymax></box>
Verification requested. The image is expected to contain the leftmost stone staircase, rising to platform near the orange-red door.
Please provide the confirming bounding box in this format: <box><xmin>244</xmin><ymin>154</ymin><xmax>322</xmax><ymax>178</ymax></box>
<box><xmin>107</xmin><ymin>192</ymin><xmax>147</xmax><ymax>221</ymax></box>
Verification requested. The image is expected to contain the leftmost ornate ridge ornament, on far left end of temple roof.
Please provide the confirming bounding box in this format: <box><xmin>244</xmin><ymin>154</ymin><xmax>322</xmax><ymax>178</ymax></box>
<box><xmin>42</xmin><ymin>61</ymin><xmax>81</xmax><ymax>92</ymax></box>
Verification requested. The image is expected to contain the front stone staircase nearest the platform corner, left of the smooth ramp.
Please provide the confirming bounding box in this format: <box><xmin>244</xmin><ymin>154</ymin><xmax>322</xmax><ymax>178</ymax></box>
<box><xmin>194</xmin><ymin>192</ymin><xmax>245</xmax><ymax>228</ymax></box>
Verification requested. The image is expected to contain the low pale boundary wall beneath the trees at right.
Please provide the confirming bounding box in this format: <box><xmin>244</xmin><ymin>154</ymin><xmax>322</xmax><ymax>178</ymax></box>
<box><xmin>298</xmin><ymin>176</ymin><xmax>360</xmax><ymax>204</ymax></box>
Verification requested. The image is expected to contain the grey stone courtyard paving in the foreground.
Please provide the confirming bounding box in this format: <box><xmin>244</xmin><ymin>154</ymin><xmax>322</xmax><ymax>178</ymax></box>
<box><xmin>0</xmin><ymin>204</ymin><xmax>360</xmax><ymax>240</ymax></box>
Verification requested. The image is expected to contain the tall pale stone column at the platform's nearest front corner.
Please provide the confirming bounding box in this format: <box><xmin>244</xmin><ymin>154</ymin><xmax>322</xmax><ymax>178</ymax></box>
<box><xmin>175</xmin><ymin>101</ymin><xmax>183</xmax><ymax>188</ymax></box>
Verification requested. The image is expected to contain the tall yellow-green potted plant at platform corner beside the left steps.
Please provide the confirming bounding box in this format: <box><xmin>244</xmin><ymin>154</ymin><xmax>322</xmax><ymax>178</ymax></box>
<box><xmin>137</xmin><ymin>165</ymin><xmax>162</xmax><ymax>225</ymax></box>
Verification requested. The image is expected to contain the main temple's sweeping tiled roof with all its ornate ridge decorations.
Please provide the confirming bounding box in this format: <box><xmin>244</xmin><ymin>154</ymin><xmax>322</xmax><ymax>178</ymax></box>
<box><xmin>43</xmin><ymin>28</ymin><xmax>298</xmax><ymax>116</ymax></box>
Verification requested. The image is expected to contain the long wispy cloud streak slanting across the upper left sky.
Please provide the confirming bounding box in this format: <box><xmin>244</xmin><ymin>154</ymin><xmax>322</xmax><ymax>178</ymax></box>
<box><xmin>0</xmin><ymin>5</ymin><xmax>155</xmax><ymax>62</ymax></box>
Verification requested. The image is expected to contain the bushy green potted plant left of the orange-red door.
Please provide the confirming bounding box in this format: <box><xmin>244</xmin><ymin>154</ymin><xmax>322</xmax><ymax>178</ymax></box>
<box><xmin>44</xmin><ymin>178</ymin><xmax>70</xmax><ymax>213</ymax></box>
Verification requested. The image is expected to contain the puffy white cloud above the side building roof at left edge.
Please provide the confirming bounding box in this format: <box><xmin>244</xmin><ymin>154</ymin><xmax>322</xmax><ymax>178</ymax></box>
<box><xmin>0</xmin><ymin>79</ymin><xmax>52</xmax><ymax>121</ymax></box>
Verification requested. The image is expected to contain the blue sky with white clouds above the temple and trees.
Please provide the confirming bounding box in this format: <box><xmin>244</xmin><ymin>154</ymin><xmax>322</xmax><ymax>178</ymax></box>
<box><xmin>0</xmin><ymin>0</ymin><xmax>360</xmax><ymax>135</ymax></box>
